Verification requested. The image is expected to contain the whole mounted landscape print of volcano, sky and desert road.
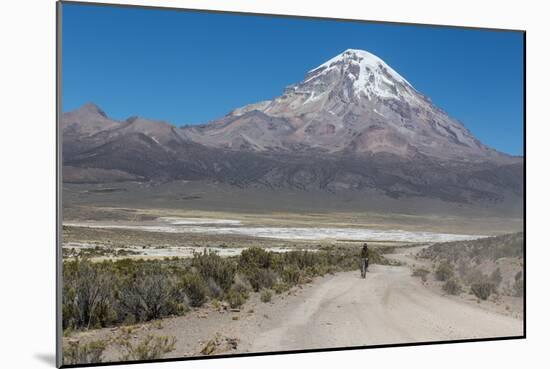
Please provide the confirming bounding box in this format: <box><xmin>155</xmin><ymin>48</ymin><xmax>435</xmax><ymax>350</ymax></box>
<box><xmin>58</xmin><ymin>2</ymin><xmax>525</xmax><ymax>366</ymax></box>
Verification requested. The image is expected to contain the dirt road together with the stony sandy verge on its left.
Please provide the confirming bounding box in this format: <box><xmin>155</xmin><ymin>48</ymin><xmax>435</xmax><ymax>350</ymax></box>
<box><xmin>86</xmin><ymin>248</ymin><xmax>523</xmax><ymax>360</ymax></box>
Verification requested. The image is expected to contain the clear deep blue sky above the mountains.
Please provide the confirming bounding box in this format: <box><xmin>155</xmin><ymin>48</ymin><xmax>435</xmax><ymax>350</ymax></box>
<box><xmin>62</xmin><ymin>3</ymin><xmax>523</xmax><ymax>155</ymax></box>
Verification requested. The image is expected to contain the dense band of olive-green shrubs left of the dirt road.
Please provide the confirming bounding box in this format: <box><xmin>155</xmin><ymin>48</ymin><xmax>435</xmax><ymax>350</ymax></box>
<box><xmin>63</xmin><ymin>247</ymin><xmax>385</xmax><ymax>330</ymax></box>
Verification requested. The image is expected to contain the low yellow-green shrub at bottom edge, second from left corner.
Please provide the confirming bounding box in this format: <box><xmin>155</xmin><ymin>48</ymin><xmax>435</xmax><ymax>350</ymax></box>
<box><xmin>117</xmin><ymin>334</ymin><xmax>176</xmax><ymax>361</ymax></box>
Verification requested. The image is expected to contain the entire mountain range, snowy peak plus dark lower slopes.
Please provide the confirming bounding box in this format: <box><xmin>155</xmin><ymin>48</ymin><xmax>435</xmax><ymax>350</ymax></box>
<box><xmin>61</xmin><ymin>50</ymin><xmax>523</xmax><ymax>207</ymax></box>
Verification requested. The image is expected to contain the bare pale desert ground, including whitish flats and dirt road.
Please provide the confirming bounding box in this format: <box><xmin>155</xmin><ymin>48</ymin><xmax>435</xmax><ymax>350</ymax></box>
<box><xmin>63</xmin><ymin>196</ymin><xmax>523</xmax><ymax>361</ymax></box>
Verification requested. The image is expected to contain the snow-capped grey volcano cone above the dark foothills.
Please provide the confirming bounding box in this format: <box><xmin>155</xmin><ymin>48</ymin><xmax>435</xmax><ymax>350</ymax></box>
<box><xmin>182</xmin><ymin>49</ymin><xmax>509</xmax><ymax>161</ymax></box>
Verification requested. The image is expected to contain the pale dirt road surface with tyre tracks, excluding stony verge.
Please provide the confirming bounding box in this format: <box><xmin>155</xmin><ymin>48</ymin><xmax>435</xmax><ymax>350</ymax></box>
<box><xmin>247</xmin><ymin>265</ymin><xmax>523</xmax><ymax>352</ymax></box>
